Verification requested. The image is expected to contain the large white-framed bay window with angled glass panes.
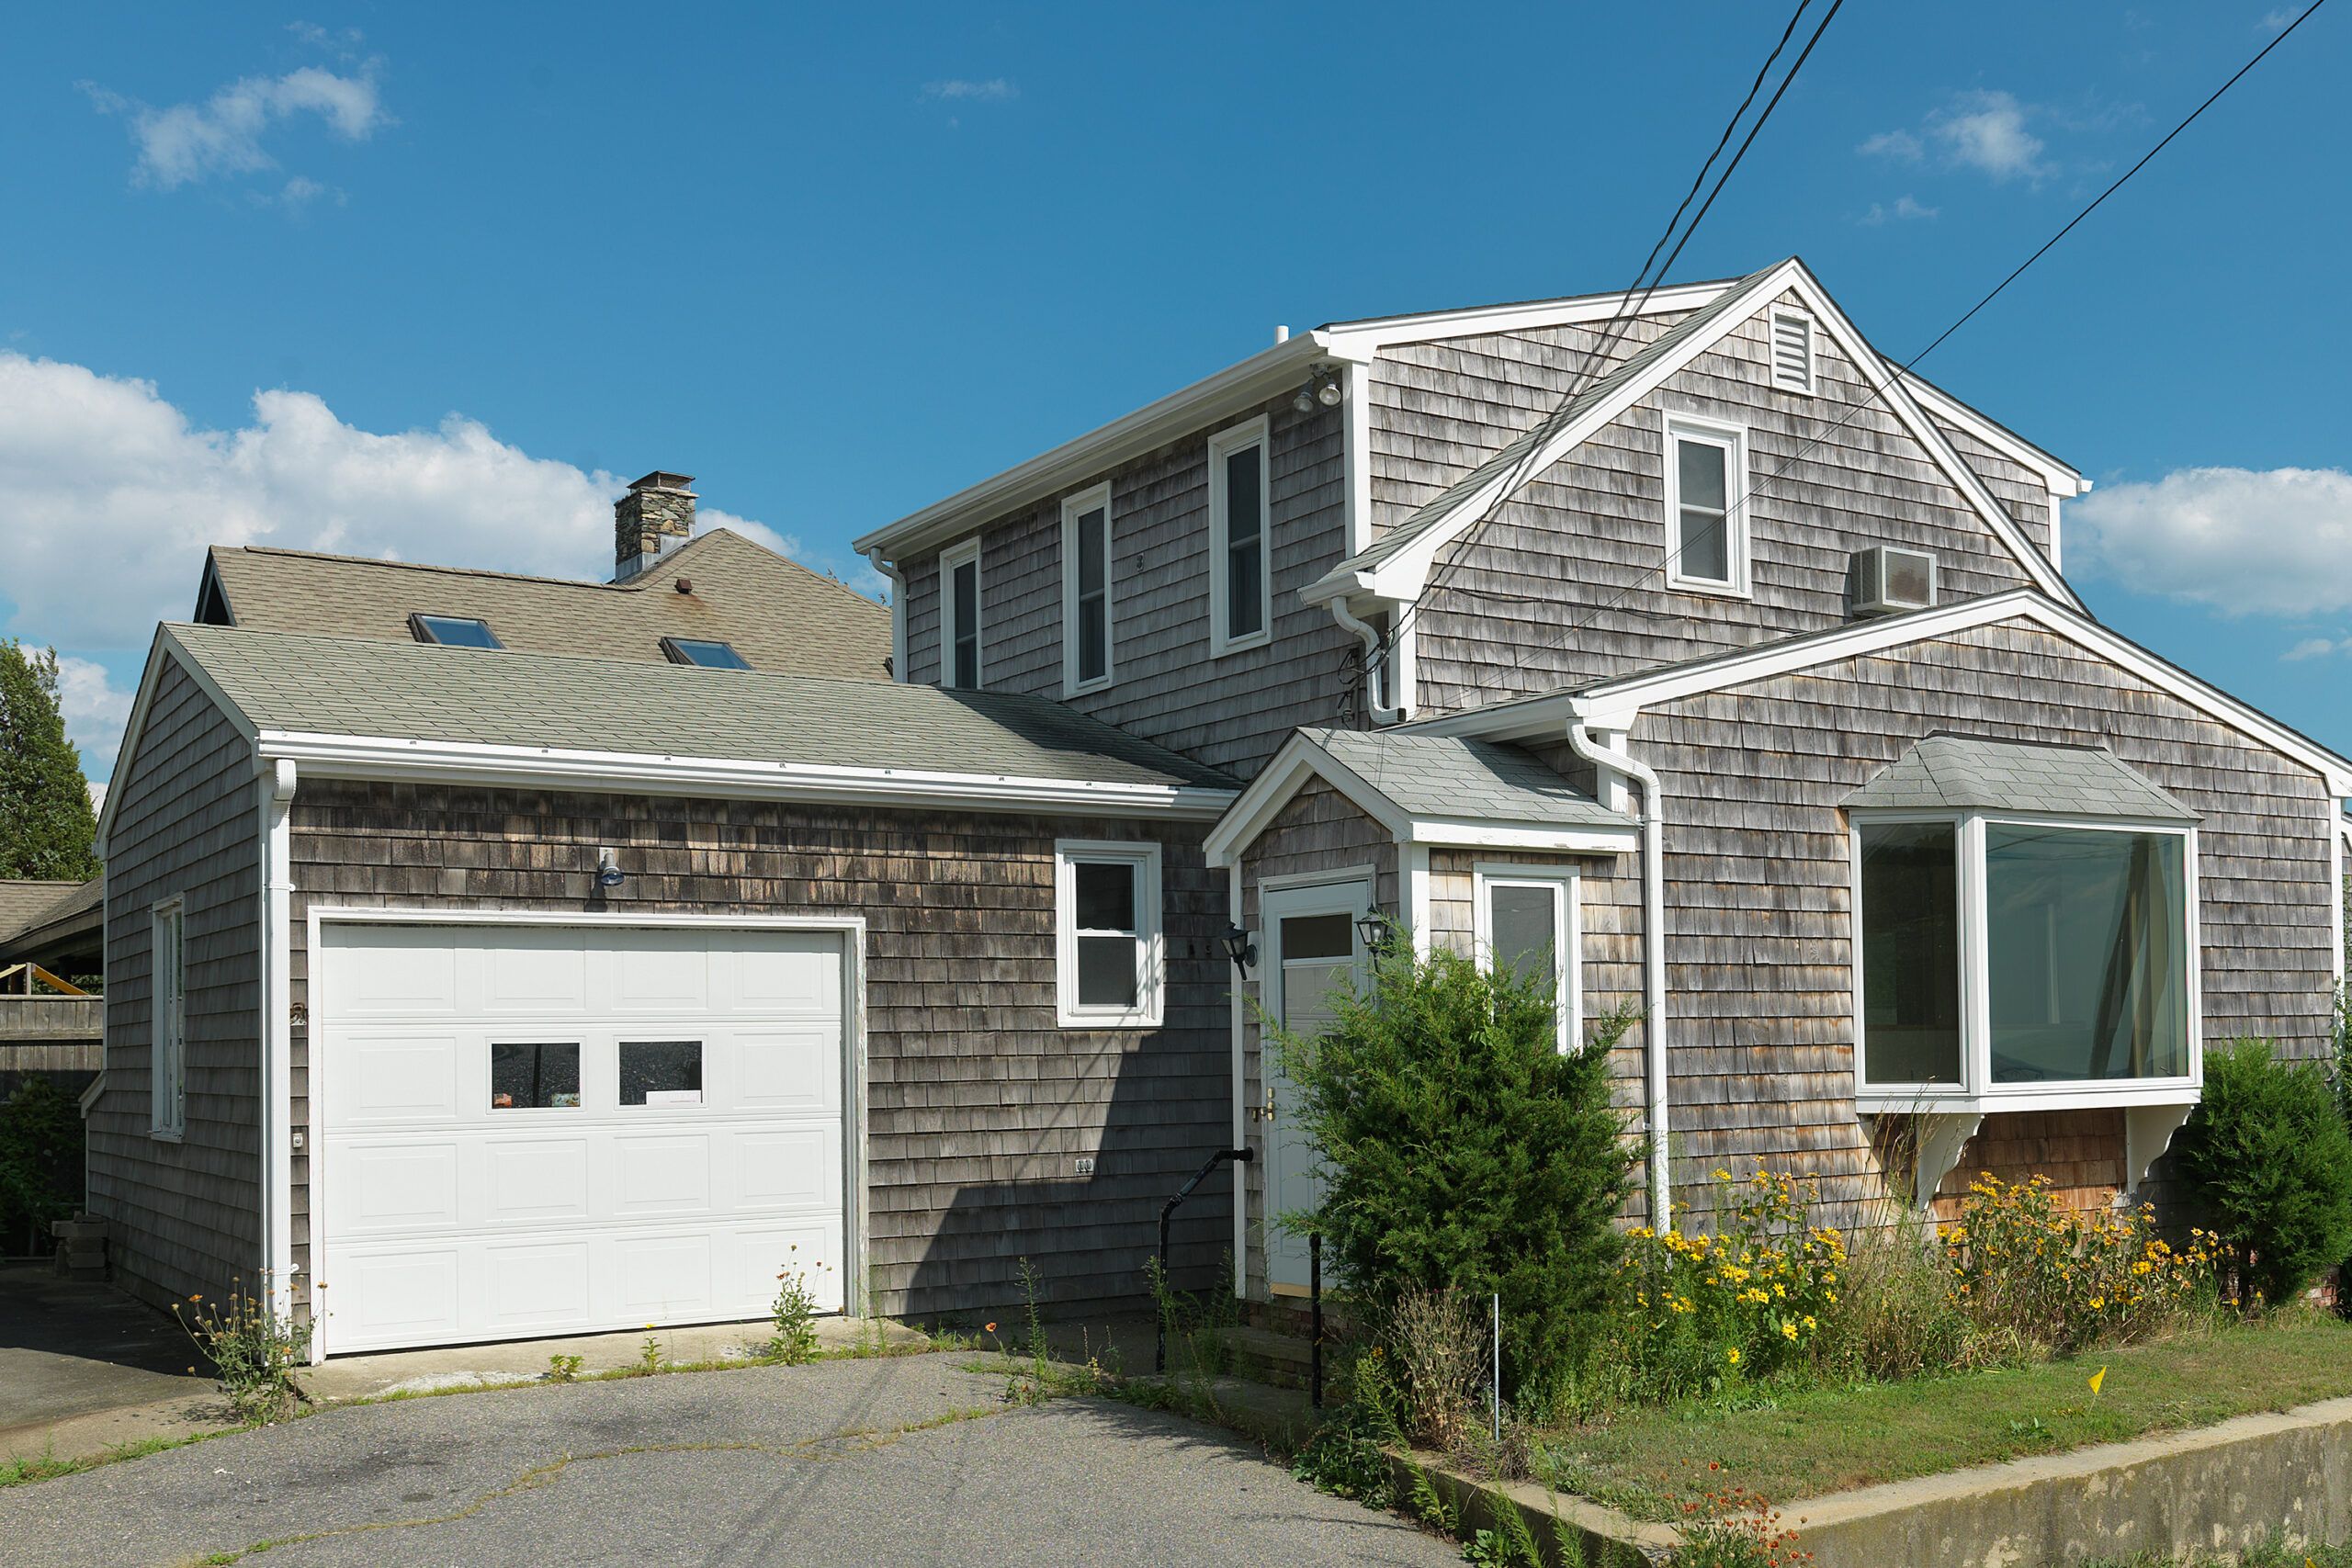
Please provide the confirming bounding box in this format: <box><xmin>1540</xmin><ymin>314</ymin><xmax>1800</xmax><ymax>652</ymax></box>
<box><xmin>1853</xmin><ymin>811</ymin><xmax>2197</xmax><ymax>1110</ymax></box>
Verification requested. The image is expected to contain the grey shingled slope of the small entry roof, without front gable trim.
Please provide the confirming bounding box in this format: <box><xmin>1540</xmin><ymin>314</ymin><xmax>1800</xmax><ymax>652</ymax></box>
<box><xmin>1298</xmin><ymin>728</ymin><xmax>1634</xmax><ymax>828</ymax></box>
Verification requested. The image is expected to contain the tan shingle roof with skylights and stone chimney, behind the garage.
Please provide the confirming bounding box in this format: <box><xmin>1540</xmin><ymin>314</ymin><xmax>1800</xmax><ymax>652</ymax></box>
<box><xmin>207</xmin><ymin>529</ymin><xmax>891</xmax><ymax>682</ymax></box>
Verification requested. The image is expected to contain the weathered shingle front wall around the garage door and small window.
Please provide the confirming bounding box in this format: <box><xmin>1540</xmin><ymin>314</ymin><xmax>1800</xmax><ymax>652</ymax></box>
<box><xmin>291</xmin><ymin>781</ymin><xmax>1232</xmax><ymax>1319</ymax></box>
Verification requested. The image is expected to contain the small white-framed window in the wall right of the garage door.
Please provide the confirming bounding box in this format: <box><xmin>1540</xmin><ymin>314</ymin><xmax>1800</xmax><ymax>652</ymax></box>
<box><xmin>1054</xmin><ymin>840</ymin><xmax>1164</xmax><ymax>1030</ymax></box>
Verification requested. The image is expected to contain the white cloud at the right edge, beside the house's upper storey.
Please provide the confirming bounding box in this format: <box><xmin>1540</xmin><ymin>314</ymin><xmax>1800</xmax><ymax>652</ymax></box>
<box><xmin>2065</xmin><ymin>468</ymin><xmax>2352</xmax><ymax>615</ymax></box>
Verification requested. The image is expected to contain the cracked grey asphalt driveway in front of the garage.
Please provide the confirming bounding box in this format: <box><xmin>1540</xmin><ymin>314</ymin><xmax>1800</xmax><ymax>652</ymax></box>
<box><xmin>0</xmin><ymin>1354</ymin><xmax>1461</xmax><ymax>1568</ymax></box>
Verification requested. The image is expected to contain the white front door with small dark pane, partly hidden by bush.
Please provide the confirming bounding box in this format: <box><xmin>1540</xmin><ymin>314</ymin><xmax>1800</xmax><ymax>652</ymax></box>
<box><xmin>1259</xmin><ymin>882</ymin><xmax>1366</xmax><ymax>1293</ymax></box>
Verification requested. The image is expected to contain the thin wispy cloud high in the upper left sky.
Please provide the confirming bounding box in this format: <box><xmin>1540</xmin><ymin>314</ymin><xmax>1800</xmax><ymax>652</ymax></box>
<box><xmin>83</xmin><ymin>66</ymin><xmax>390</xmax><ymax>190</ymax></box>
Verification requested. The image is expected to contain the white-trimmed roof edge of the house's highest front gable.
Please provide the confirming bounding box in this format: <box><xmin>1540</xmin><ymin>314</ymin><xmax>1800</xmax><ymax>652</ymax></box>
<box><xmin>1301</xmin><ymin>256</ymin><xmax>2082</xmax><ymax>609</ymax></box>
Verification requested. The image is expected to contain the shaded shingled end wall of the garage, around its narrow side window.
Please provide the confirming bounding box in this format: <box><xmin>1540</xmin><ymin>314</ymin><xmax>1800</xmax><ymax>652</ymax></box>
<box><xmin>89</xmin><ymin>665</ymin><xmax>261</xmax><ymax>1300</ymax></box>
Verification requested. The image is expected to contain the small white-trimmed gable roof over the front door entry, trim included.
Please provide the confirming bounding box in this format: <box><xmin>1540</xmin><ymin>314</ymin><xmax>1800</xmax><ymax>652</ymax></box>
<box><xmin>1206</xmin><ymin>727</ymin><xmax>1637</xmax><ymax>865</ymax></box>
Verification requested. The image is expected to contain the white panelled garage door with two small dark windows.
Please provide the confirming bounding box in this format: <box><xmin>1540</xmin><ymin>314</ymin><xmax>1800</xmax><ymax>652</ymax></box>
<box><xmin>311</xmin><ymin>921</ymin><xmax>847</xmax><ymax>1352</ymax></box>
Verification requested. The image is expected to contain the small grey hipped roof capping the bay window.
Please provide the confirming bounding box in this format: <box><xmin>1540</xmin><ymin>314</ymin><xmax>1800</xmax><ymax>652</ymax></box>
<box><xmin>1841</xmin><ymin>736</ymin><xmax>2197</xmax><ymax>823</ymax></box>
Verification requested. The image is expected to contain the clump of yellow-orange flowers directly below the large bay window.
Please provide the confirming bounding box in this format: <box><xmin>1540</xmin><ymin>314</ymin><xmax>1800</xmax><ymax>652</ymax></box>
<box><xmin>1938</xmin><ymin>1176</ymin><xmax>2213</xmax><ymax>1352</ymax></box>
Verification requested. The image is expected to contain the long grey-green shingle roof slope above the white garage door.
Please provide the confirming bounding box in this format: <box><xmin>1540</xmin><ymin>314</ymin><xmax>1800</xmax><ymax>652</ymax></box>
<box><xmin>164</xmin><ymin>626</ymin><xmax>1239</xmax><ymax>790</ymax></box>
